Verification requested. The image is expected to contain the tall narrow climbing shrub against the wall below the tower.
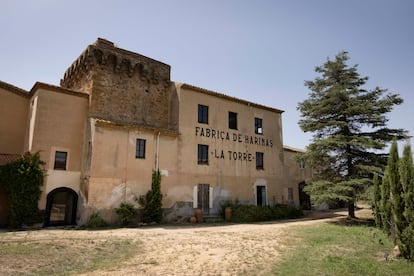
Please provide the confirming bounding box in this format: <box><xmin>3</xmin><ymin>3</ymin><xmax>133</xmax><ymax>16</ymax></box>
<box><xmin>138</xmin><ymin>170</ymin><xmax>162</xmax><ymax>223</ymax></box>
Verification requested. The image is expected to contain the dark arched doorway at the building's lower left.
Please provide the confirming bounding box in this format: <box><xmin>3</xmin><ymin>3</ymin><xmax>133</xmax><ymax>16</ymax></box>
<box><xmin>45</xmin><ymin>187</ymin><xmax>78</xmax><ymax>226</ymax></box>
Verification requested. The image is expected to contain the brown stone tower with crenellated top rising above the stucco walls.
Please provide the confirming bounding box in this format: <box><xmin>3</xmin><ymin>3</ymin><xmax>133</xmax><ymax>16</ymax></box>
<box><xmin>61</xmin><ymin>38</ymin><xmax>174</xmax><ymax>129</ymax></box>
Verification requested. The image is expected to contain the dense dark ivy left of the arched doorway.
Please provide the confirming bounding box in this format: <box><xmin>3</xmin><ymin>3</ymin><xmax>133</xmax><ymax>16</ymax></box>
<box><xmin>0</xmin><ymin>152</ymin><xmax>45</xmax><ymax>228</ymax></box>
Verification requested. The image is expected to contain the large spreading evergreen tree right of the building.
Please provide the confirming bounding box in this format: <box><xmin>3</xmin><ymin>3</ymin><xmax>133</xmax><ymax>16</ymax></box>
<box><xmin>298</xmin><ymin>52</ymin><xmax>406</xmax><ymax>217</ymax></box>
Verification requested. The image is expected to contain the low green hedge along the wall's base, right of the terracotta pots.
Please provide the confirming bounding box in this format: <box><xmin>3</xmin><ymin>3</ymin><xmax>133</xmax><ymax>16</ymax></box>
<box><xmin>231</xmin><ymin>204</ymin><xmax>303</xmax><ymax>222</ymax></box>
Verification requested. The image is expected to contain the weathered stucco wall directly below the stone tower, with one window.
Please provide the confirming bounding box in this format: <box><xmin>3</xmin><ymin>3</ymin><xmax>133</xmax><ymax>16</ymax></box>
<box><xmin>87</xmin><ymin>122</ymin><xmax>181</xmax><ymax>219</ymax></box>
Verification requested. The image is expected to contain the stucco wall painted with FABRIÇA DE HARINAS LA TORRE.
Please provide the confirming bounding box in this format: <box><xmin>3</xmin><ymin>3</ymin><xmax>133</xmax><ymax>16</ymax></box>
<box><xmin>173</xmin><ymin>85</ymin><xmax>285</xmax><ymax>210</ymax></box>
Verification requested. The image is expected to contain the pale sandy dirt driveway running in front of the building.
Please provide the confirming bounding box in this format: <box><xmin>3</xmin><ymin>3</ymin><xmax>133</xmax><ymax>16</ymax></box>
<box><xmin>0</xmin><ymin>210</ymin><xmax>363</xmax><ymax>275</ymax></box>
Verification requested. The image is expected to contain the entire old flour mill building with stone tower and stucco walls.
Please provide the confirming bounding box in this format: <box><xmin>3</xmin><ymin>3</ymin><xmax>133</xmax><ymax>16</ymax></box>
<box><xmin>0</xmin><ymin>39</ymin><xmax>311</xmax><ymax>225</ymax></box>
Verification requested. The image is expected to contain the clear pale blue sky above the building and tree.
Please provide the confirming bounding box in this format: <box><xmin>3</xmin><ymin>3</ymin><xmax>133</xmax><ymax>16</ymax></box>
<box><xmin>0</xmin><ymin>0</ymin><xmax>414</xmax><ymax>149</ymax></box>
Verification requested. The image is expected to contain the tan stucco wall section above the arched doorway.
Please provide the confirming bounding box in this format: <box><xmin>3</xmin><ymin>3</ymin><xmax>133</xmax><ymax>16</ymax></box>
<box><xmin>26</xmin><ymin>83</ymin><xmax>88</xmax><ymax>209</ymax></box>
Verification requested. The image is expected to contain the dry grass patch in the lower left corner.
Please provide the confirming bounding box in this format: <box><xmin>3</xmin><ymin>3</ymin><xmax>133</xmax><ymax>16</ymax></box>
<box><xmin>0</xmin><ymin>231</ymin><xmax>139</xmax><ymax>275</ymax></box>
